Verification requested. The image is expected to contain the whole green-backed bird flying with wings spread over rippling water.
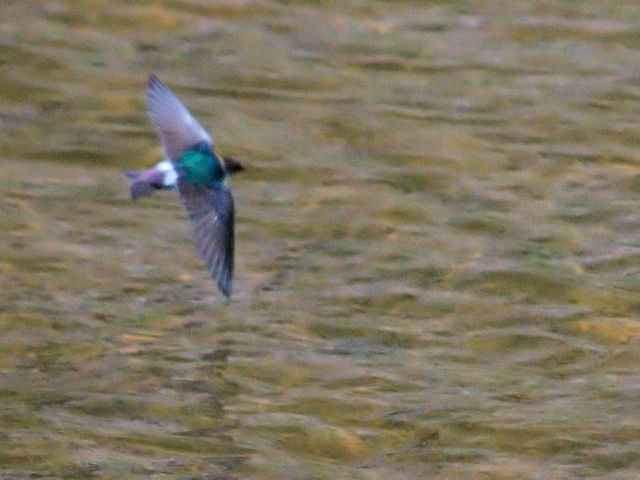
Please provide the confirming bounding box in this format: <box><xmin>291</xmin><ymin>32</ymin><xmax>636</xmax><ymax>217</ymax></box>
<box><xmin>125</xmin><ymin>75</ymin><xmax>243</xmax><ymax>297</ymax></box>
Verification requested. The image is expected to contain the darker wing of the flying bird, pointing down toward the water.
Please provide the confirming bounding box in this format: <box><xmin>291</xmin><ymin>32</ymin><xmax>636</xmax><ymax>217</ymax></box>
<box><xmin>178</xmin><ymin>178</ymin><xmax>234</xmax><ymax>297</ymax></box>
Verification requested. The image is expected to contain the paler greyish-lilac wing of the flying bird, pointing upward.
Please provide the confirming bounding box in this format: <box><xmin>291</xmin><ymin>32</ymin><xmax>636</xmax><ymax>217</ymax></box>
<box><xmin>147</xmin><ymin>74</ymin><xmax>213</xmax><ymax>162</ymax></box>
